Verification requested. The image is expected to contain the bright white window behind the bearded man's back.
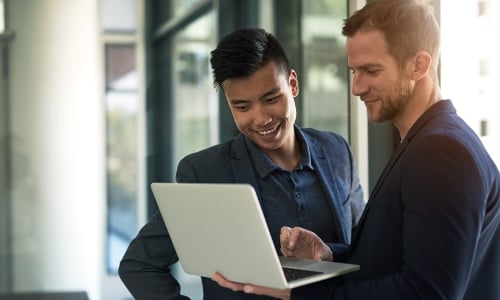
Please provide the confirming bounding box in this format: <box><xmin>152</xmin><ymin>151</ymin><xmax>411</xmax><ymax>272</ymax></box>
<box><xmin>441</xmin><ymin>0</ymin><xmax>500</xmax><ymax>165</ymax></box>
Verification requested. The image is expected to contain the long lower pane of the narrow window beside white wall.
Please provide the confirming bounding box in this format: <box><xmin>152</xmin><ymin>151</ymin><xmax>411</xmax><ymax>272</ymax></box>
<box><xmin>106</xmin><ymin>45</ymin><xmax>138</xmax><ymax>273</ymax></box>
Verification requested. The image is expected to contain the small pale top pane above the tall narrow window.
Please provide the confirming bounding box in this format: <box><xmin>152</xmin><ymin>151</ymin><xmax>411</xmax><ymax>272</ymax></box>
<box><xmin>101</xmin><ymin>0</ymin><xmax>136</xmax><ymax>33</ymax></box>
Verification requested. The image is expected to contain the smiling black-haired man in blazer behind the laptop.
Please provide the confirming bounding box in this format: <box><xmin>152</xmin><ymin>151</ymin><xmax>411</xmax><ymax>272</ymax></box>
<box><xmin>119</xmin><ymin>28</ymin><xmax>364</xmax><ymax>300</ymax></box>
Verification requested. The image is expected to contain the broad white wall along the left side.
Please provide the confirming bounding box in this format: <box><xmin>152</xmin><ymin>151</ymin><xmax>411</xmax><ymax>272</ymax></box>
<box><xmin>6</xmin><ymin>0</ymin><xmax>105</xmax><ymax>299</ymax></box>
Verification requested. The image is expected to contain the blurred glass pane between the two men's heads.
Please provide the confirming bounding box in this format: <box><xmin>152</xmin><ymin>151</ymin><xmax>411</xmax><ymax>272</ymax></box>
<box><xmin>299</xmin><ymin>0</ymin><xmax>349</xmax><ymax>138</ymax></box>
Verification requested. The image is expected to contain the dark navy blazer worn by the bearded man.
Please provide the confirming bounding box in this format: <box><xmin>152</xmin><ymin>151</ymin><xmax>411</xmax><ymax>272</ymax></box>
<box><xmin>292</xmin><ymin>100</ymin><xmax>500</xmax><ymax>300</ymax></box>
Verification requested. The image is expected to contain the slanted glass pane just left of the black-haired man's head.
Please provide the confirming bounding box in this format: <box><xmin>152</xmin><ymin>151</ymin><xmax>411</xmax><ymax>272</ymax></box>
<box><xmin>173</xmin><ymin>13</ymin><xmax>218</xmax><ymax>169</ymax></box>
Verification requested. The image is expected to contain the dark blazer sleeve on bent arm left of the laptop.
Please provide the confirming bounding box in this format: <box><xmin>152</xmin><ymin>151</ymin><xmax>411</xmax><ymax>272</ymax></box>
<box><xmin>118</xmin><ymin>212</ymin><xmax>189</xmax><ymax>300</ymax></box>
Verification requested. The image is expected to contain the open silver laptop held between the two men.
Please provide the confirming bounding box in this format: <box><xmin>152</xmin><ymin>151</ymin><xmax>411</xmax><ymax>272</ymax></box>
<box><xmin>151</xmin><ymin>183</ymin><xmax>359</xmax><ymax>289</ymax></box>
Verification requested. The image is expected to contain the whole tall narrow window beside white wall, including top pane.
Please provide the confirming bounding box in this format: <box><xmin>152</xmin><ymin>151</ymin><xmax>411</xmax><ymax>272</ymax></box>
<box><xmin>100</xmin><ymin>0</ymin><xmax>143</xmax><ymax>276</ymax></box>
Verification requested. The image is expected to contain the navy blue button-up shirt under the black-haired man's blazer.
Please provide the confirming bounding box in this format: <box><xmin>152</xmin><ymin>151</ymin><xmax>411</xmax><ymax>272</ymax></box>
<box><xmin>245</xmin><ymin>131</ymin><xmax>338</xmax><ymax>255</ymax></box>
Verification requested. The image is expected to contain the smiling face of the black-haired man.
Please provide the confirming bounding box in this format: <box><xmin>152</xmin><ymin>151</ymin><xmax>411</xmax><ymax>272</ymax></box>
<box><xmin>222</xmin><ymin>62</ymin><xmax>299</xmax><ymax>152</ymax></box>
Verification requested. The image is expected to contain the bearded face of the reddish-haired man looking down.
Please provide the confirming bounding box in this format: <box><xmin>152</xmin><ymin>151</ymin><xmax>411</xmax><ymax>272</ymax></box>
<box><xmin>346</xmin><ymin>30</ymin><xmax>414</xmax><ymax>123</ymax></box>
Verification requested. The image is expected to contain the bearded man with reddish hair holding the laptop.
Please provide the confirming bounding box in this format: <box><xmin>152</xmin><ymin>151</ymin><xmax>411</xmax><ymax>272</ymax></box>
<box><xmin>214</xmin><ymin>0</ymin><xmax>500</xmax><ymax>300</ymax></box>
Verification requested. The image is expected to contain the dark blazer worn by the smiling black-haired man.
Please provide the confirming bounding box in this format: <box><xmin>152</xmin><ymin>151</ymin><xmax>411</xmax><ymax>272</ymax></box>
<box><xmin>119</xmin><ymin>128</ymin><xmax>364</xmax><ymax>300</ymax></box>
